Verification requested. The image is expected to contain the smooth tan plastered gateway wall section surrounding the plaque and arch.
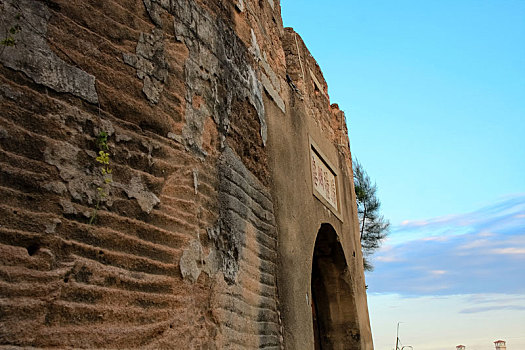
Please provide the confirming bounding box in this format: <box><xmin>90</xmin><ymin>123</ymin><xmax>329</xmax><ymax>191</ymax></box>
<box><xmin>266</xmin><ymin>28</ymin><xmax>373</xmax><ymax>349</ymax></box>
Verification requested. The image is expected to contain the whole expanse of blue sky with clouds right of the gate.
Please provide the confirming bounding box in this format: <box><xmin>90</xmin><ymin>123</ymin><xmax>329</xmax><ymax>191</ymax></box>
<box><xmin>281</xmin><ymin>0</ymin><xmax>525</xmax><ymax>350</ymax></box>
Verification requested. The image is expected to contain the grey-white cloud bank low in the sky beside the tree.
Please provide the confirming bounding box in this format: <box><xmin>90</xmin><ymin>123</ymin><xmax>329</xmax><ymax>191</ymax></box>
<box><xmin>367</xmin><ymin>194</ymin><xmax>525</xmax><ymax>296</ymax></box>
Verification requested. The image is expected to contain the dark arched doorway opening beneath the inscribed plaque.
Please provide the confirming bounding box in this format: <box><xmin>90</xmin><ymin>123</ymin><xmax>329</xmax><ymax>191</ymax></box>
<box><xmin>312</xmin><ymin>224</ymin><xmax>361</xmax><ymax>350</ymax></box>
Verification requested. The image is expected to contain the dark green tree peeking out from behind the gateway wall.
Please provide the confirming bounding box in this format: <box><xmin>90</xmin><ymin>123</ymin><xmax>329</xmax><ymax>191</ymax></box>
<box><xmin>353</xmin><ymin>160</ymin><xmax>390</xmax><ymax>271</ymax></box>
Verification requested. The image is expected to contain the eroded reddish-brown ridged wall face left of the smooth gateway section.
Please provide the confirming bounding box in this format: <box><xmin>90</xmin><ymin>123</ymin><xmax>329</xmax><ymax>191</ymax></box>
<box><xmin>0</xmin><ymin>0</ymin><xmax>283</xmax><ymax>349</ymax></box>
